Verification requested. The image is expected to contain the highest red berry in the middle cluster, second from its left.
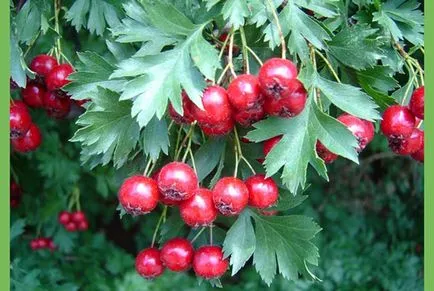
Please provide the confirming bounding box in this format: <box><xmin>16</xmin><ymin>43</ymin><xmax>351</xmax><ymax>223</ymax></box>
<box><xmin>158</xmin><ymin>162</ymin><xmax>199</xmax><ymax>201</ymax></box>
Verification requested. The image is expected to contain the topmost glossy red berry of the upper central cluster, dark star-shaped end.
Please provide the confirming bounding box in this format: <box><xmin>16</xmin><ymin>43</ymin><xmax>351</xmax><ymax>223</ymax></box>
<box><xmin>258</xmin><ymin>58</ymin><xmax>297</xmax><ymax>99</ymax></box>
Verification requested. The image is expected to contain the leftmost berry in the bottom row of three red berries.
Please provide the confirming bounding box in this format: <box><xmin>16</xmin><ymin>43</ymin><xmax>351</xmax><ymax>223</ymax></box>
<box><xmin>136</xmin><ymin>248</ymin><xmax>164</xmax><ymax>279</ymax></box>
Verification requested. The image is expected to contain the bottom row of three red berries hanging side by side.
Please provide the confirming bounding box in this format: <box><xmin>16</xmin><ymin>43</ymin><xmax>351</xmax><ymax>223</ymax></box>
<box><xmin>136</xmin><ymin>237</ymin><xmax>229</xmax><ymax>279</ymax></box>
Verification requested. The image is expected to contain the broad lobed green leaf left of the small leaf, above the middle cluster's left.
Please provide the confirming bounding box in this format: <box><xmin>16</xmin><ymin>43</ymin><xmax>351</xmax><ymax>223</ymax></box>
<box><xmin>71</xmin><ymin>88</ymin><xmax>139</xmax><ymax>167</ymax></box>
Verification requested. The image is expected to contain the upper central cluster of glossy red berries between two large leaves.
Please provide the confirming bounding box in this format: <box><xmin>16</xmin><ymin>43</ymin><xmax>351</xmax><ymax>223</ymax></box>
<box><xmin>169</xmin><ymin>58</ymin><xmax>307</xmax><ymax>136</ymax></box>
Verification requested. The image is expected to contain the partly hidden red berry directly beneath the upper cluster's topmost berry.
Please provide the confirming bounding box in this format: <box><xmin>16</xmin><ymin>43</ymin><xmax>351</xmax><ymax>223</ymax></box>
<box><xmin>264</xmin><ymin>79</ymin><xmax>307</xmax><ymax>118</ymax></box>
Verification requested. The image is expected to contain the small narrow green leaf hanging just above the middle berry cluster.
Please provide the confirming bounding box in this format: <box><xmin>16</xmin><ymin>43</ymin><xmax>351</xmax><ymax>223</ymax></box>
<box><xmin>143</xmin><ymin>117</ymin><xmax>169</xmax><ymax>162</ymax></box>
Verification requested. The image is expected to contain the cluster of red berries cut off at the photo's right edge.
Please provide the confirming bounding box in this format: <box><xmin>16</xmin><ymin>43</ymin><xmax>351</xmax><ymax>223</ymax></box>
<box><xmin>381</xmin><ymin>87</ymin><xmax>425</xmax><ymax>162</ymax></box>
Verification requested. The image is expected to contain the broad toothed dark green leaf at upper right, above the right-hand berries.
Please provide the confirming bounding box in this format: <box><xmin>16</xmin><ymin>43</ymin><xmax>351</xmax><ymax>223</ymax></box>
<box><xmin>328</xmin><ymin>25</ymin><xmax>384</xmax><ymax>70</ymax></box>
